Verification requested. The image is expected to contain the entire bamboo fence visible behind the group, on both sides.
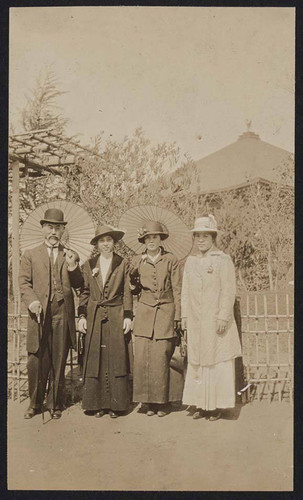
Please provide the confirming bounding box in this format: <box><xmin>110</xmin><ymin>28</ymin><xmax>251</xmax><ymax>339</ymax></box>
<box><xmin>8</xmin><ymin>291</ymin><xmax>294</xmax><ymax>402</ymax></box>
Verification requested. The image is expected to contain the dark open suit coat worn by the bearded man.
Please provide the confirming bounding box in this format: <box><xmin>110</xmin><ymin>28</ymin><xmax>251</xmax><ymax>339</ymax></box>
<box><xmin>19</xmin><ymin>243</ymin><xmax>83</xmax><ymax>353</ymax></box>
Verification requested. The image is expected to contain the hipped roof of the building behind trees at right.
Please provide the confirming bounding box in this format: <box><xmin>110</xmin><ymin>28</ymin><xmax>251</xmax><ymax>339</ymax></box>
<box><xmin>190</xmin><ymin>130</ymin><xmax>291</xmax><ymax>192</ymax></box>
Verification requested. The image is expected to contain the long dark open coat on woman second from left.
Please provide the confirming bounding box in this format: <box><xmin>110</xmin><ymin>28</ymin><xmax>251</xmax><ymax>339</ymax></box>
<box><xmin>78</xmin><ymin>253</ymin><xmax>133</xmax><ymax>379</ymax></box>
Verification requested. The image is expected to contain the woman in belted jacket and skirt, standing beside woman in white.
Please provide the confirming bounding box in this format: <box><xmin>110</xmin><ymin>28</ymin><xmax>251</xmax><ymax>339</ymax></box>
<box><xmin>130</xmin><ymin>221</ymin><xmax>181</xmax><ymax>417</ymax></box>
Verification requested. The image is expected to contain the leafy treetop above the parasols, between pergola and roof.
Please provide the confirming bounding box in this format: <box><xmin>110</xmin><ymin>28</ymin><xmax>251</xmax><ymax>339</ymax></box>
<box><xmin>64</xmin><ymin>128</ymin><xmax>179</xmax><ymax>225</ymax></box>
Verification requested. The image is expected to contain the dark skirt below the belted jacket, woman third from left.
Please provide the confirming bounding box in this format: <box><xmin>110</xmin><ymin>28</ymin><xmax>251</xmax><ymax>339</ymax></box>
<box><xmin>133</xmin><ymin>337</ymin><xmax>176</xmax><ymax>404</ymax></box>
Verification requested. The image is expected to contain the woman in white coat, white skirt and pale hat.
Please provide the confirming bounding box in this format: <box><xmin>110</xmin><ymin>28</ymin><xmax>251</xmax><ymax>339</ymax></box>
<box><xmin>181</xmin><ymin>215</ymin><xmax>241</xmax><ymax>420</ymax></box>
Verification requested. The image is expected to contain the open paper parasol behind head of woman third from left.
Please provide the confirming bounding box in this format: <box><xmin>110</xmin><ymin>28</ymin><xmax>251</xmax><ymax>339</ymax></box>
<box><xmin>119</xmin><ymin>205</ymin><xmax>192</xmax><ymax>260</ymax></box>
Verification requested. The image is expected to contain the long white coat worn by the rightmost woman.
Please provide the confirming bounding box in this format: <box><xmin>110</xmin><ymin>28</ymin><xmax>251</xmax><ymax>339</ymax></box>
<box><xmin>181</xmin><ymin>249</ymin><xmax>241</xmax><ymax>366</ymax></box>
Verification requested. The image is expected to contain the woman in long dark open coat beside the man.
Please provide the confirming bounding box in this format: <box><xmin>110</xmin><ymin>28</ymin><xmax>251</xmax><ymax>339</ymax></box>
<box><xmin>78</xmin><ymin>226</ymin><xmax>132</xmax><ymax>418</ymax></box>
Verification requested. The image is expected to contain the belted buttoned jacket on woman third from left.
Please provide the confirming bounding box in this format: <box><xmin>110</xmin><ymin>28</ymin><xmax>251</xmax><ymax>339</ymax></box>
<box><xmin>130</xmin><ymin>250</ymin><xmax>181</xmax><ymax>339</ymax></box>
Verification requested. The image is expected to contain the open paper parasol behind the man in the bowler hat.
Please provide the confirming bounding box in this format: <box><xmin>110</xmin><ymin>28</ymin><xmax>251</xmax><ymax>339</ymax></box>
<box><xmin>20</xmin><ymin>200</ymin><xmax>95</xmax><ymax>263</ymax></box>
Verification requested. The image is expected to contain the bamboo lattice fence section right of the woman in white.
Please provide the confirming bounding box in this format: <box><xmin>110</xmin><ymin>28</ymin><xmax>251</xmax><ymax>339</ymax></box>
<box><xmin>241</xmin><ymin>292</ymin><xmax>294</xmax><ymax>402</ymax></box>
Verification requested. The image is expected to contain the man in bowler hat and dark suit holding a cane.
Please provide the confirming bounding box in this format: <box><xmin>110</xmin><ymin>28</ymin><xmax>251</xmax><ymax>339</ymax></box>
<box><xmin>19</xmin><ymin>208</ymin><xmax>83</xmax><ymax>419</ymax></box>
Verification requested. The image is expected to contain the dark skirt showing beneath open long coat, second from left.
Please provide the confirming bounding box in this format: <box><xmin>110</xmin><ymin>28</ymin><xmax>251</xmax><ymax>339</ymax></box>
<box><xmin>82</xmin><ymin>322</ymin><xmax>129</xmax><ymax>411</ymax></box>
